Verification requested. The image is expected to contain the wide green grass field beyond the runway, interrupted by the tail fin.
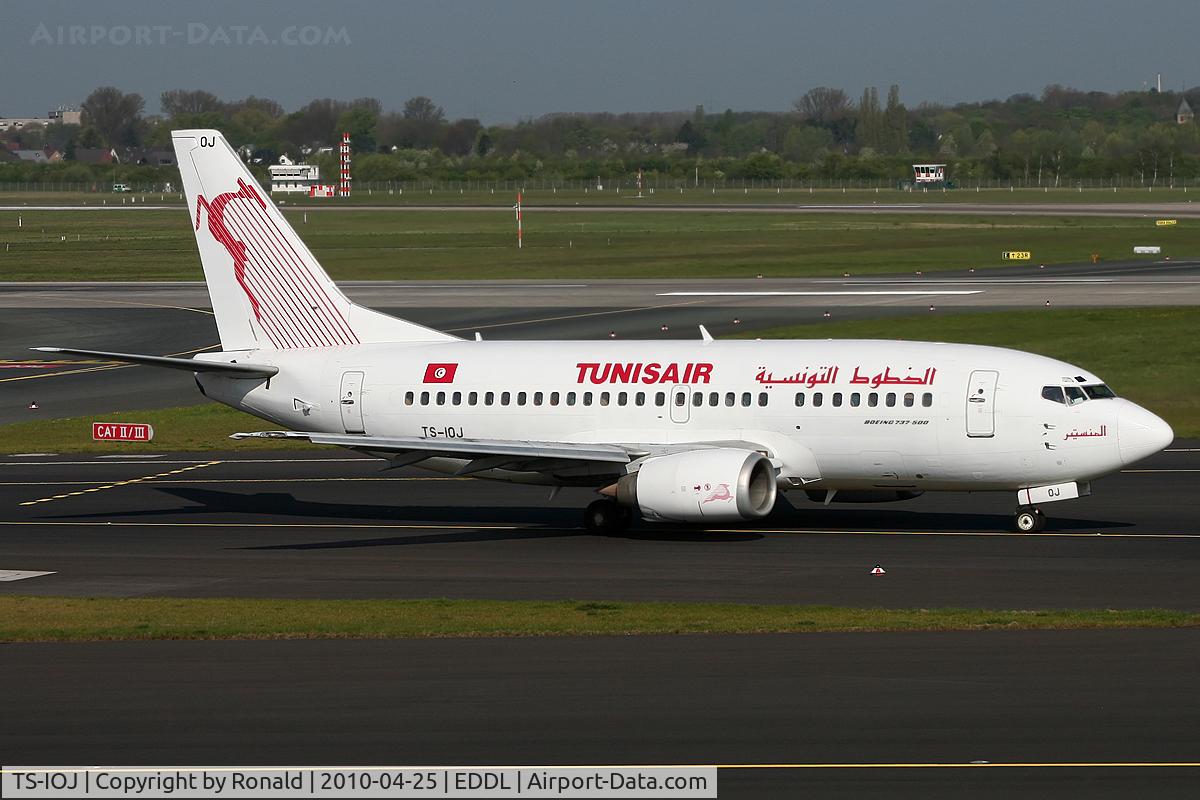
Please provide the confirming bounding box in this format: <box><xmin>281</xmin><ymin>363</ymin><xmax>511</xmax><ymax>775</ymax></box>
<box><xmin>0</xmin><ymin>205</ymin><xmax>1200</xmax><ymax>282</ymax></box>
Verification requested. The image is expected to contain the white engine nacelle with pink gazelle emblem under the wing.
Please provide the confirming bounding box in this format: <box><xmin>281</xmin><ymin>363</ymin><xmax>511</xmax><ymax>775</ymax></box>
<box><xmin>617</xmin><ymin>447</ymin><xmax>775</xmax><ymax>522</ymax></box>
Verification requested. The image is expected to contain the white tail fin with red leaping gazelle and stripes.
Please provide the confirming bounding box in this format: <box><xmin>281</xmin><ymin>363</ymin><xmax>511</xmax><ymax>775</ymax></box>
<box><xmin>170</xmin><ymin>131</ymin><xmax>456</xmax><ymax>350</ymax></box>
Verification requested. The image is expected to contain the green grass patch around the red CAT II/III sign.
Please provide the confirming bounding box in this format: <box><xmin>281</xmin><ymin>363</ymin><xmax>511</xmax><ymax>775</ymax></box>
<box><xmin>0</xmin><ymin>403</ymin><xmax>318</xmax><ymax>453</ymax></box>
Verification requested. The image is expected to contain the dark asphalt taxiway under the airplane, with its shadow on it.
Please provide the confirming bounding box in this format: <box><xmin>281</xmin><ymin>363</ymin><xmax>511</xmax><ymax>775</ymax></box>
<box><xmin>0</xmin><ymin>441</ymin><xmax>1200</xmax><ymax>609</ymax></box>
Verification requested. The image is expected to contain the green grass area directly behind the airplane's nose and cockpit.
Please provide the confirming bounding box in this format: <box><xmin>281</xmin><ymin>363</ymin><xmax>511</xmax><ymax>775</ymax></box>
<box><xmin>743</xmin><ymin>307</ymin><xmax>1200</xmax><ymax>437</ymax></box>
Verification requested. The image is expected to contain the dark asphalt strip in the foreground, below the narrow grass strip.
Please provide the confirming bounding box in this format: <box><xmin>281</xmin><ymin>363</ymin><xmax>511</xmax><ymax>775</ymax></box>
<box><xmin>0</xmin><ymin>630</ymin><xmax>1200</xmax><ymax>798</ymax></box>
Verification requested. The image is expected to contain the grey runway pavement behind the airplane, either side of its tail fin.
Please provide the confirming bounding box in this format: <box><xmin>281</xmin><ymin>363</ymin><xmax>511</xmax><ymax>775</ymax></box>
<box><xmin>0</xmin><ymin>260</ymin><xmax>1200</xmax><ymax>425</ymax></box>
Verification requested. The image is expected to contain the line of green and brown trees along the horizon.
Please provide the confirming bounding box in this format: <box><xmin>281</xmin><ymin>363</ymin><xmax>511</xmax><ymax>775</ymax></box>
<box><xmin>0</xmin><ymin>84</ymin><xmax>1200</xmax><ymax>186</ymax></box>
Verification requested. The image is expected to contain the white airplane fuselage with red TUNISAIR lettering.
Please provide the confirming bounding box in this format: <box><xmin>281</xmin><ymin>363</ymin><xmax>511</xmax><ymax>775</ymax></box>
<box><xmin>198</xmin><ymin>341</ymin><xmax>1170</xmax><ymax>491</ymax></box>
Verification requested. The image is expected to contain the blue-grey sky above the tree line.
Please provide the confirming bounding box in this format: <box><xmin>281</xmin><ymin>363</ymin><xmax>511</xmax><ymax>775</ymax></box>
<box><xmin>0</xmin><ymin>0</ymin><xmax>1200</xmax><ymax>124</ymax></box>
